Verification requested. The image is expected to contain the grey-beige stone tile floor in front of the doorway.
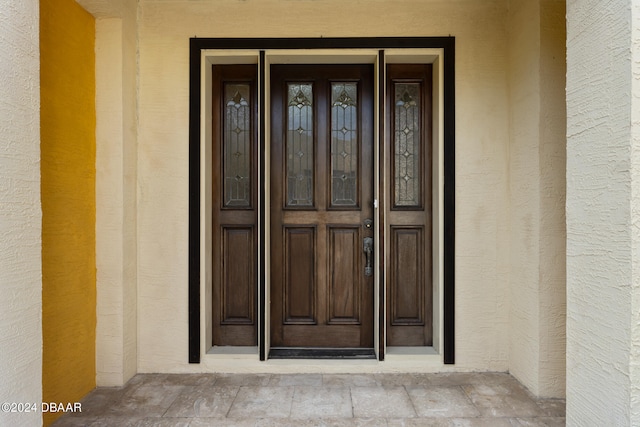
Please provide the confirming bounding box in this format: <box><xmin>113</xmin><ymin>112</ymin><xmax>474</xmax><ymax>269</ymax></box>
<box><xmin>53</xmin><ymin>373</ymin><xmax>565</xmax><ymax>427</ymax></box>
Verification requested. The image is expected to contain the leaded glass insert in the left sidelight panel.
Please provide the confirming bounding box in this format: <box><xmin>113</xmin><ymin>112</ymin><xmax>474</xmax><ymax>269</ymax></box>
<box><xmin>222</xmin><ymin>83</ymin><xmax>252</xmax><ymax>207</ymax></box>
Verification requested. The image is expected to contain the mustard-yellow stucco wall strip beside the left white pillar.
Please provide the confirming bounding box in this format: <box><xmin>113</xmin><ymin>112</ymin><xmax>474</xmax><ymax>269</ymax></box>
<box><xmin>40</xmin><ymin>0</ymin><xmax>96</xmax><ymax>425</ymax></box>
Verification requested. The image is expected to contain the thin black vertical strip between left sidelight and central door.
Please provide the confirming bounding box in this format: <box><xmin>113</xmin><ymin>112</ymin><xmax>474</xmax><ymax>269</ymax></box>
<box><xmin>258</xmin><ymin>50</ymin><xmax>267</xmax><ymax>361</ymax></box>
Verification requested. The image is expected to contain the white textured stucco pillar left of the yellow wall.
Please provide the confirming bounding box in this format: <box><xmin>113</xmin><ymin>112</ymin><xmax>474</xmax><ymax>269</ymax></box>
<box><xmin>0</xmin><ymin>0</ymin><xmax>42</xmax><ymax>426</ymax></box>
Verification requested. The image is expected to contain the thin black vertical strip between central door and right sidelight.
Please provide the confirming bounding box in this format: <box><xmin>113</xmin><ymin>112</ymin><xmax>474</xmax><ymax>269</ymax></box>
<box><xmin>376</xmin><ymin>49</ymin><xmax>387</xmax><ymax>362</ymax></box>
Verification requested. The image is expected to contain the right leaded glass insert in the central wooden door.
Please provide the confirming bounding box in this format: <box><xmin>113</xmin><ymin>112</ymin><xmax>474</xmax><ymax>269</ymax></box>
<box><xmin>331</xmin><ymin>83</ymin><xmax>358</xmax><ymax>206</ymax></box>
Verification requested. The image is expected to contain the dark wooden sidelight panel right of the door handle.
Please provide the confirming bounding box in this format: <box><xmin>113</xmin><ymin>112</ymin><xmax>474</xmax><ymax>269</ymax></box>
<box><xmin>384</xmin><ymin>64</ymin><xmax>433</xmax><ymax>346</ymax></box>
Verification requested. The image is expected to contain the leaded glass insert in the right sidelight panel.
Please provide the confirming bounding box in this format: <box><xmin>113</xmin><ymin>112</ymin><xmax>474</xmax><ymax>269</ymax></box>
<box><xmin>393</xmin><ymin>83</ymin><xmax>422</xmax><ymax>207</ymax></box>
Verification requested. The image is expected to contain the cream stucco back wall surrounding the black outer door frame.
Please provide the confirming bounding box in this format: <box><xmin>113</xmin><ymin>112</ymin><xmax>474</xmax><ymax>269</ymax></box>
<box><xmin>138</xmin><ymin>0</ymin><xmax>509</xmax><ymax>372</ymax></box>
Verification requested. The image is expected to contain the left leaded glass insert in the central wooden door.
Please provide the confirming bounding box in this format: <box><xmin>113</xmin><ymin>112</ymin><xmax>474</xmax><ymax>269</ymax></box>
<box><xmin>286</xmin><ymin>83</ymin><xmax>314</xmax><ymax>207</ymax></box>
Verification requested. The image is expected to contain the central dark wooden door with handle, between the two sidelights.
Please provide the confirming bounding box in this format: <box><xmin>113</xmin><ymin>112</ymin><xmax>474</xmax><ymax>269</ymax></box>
<box><xmin>270</xmin><ymin>64</ymin><xmax>373</xmax><ymax>348</ymax></box>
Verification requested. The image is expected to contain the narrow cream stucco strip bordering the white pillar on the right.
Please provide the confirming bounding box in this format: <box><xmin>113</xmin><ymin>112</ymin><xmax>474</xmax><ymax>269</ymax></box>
<box><xmin>536</xmin><ymin>0</ymin><xmax>567</xmax><ymax>397</ymax></box>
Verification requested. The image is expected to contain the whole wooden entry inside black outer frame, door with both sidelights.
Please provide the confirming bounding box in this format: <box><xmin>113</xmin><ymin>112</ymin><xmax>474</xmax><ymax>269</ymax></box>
<box><xmin>190</xmin><ymin>38</ymin><xmax>453</xmax><ymax>363</ymax></box>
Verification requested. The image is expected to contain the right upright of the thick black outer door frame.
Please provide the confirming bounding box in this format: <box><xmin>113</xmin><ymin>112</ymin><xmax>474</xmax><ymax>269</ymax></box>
<box><xmin>443</xmin><ymin>37</ymin><xmax>456</xmax><ymax>365</ymax></box>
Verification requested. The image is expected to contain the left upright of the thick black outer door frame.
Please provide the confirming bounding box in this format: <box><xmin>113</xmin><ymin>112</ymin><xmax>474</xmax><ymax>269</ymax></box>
<box><xmin>189</xmin><ymin>39</ymin><xmax>201</xmax><ymax>363</ymax></box>
